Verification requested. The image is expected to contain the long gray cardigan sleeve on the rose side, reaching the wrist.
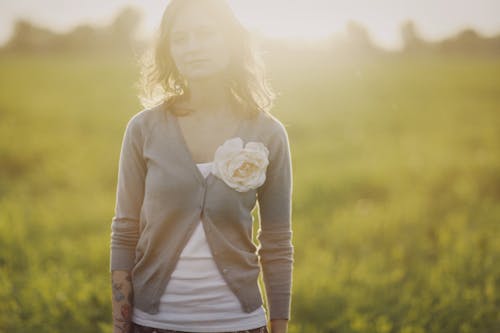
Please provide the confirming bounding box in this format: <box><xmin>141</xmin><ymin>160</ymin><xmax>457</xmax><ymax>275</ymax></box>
<box><xmin>257</xmin><ymin>122</ymin><xmax>294</xmax><ymax>319</ymax></box>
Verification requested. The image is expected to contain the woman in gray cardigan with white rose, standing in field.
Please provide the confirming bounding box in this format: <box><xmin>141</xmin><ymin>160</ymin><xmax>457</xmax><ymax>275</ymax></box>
<box><xmin>110</xmin><ymin>0</ymin><xmax>293</xmax><ymax>333</ymax></box>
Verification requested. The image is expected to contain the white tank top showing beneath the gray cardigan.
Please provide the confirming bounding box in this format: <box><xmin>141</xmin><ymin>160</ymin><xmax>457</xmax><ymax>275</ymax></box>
<box><xmin>132</xmin><ymin>162</ymin><xmax>267</xmax><ymax>332</ymax></box>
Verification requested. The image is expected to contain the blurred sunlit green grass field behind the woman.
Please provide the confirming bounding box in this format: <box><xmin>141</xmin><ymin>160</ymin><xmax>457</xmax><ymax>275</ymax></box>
<box><xmin>0</xmin><ymin>50</ymin><xmax>500</xmax><ymax>333</ymax></box>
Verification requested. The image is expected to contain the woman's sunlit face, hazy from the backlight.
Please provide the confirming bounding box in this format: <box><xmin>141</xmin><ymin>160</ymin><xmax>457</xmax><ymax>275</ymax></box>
<box><xmin>169</xmin><ymin>5</ymin><xmax>230</xmax><ymax>81</ymax></box>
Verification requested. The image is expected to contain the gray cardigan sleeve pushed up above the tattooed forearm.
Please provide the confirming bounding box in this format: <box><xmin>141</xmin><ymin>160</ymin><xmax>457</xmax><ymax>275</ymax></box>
<box><xmin>110</xmin><ymin>115</ymin><xmax>146</xmax><ymax>271</ymax></box>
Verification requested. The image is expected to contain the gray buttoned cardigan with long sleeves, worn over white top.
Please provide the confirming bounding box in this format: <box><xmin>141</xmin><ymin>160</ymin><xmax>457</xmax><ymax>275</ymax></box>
<box><xmin>110</xmin><ymin>105</ymin><xmax>294</xmax><ymax>319</ymax></box>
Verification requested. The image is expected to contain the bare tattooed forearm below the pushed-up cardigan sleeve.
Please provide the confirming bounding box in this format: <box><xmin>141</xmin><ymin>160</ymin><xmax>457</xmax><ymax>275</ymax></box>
<box><xmin>111</xmin><ymin>270</ymin><xmax>134</xmax><ymax>333</ymax></box>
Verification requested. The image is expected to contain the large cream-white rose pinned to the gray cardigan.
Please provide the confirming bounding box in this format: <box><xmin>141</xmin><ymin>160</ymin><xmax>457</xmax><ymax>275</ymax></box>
<box><xmin>212</xmin><ymin>137</ymin><xmax>269</xmax><ymax>192</ymax></box>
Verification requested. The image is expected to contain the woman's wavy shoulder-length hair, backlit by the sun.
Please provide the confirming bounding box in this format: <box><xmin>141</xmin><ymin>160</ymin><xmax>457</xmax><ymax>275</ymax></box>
<box><xmin>138</xmin><ymin>0</ymin><xmax>275</xmax><ymax>115</ymax></box>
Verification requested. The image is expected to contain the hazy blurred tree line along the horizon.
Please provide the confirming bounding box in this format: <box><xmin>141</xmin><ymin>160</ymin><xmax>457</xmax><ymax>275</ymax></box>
<box><xmin>0</xmin><ymin>7</ymin><xmax>500</xmax><ymax>56</ymax></box>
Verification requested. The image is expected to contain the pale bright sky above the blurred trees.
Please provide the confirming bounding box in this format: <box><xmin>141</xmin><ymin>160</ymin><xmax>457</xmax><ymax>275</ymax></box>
<box><xmin>0</xmin><ymin>0</ymin><xmax>500</xmax><ymax>50</ymax></box>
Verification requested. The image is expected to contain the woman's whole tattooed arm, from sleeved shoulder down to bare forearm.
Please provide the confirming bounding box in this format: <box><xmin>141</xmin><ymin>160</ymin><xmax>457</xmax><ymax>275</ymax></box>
<box><xmin>110</xmin><ymin>116</ymin><xmax>147</xmax><ymax>333</ymax></box>
